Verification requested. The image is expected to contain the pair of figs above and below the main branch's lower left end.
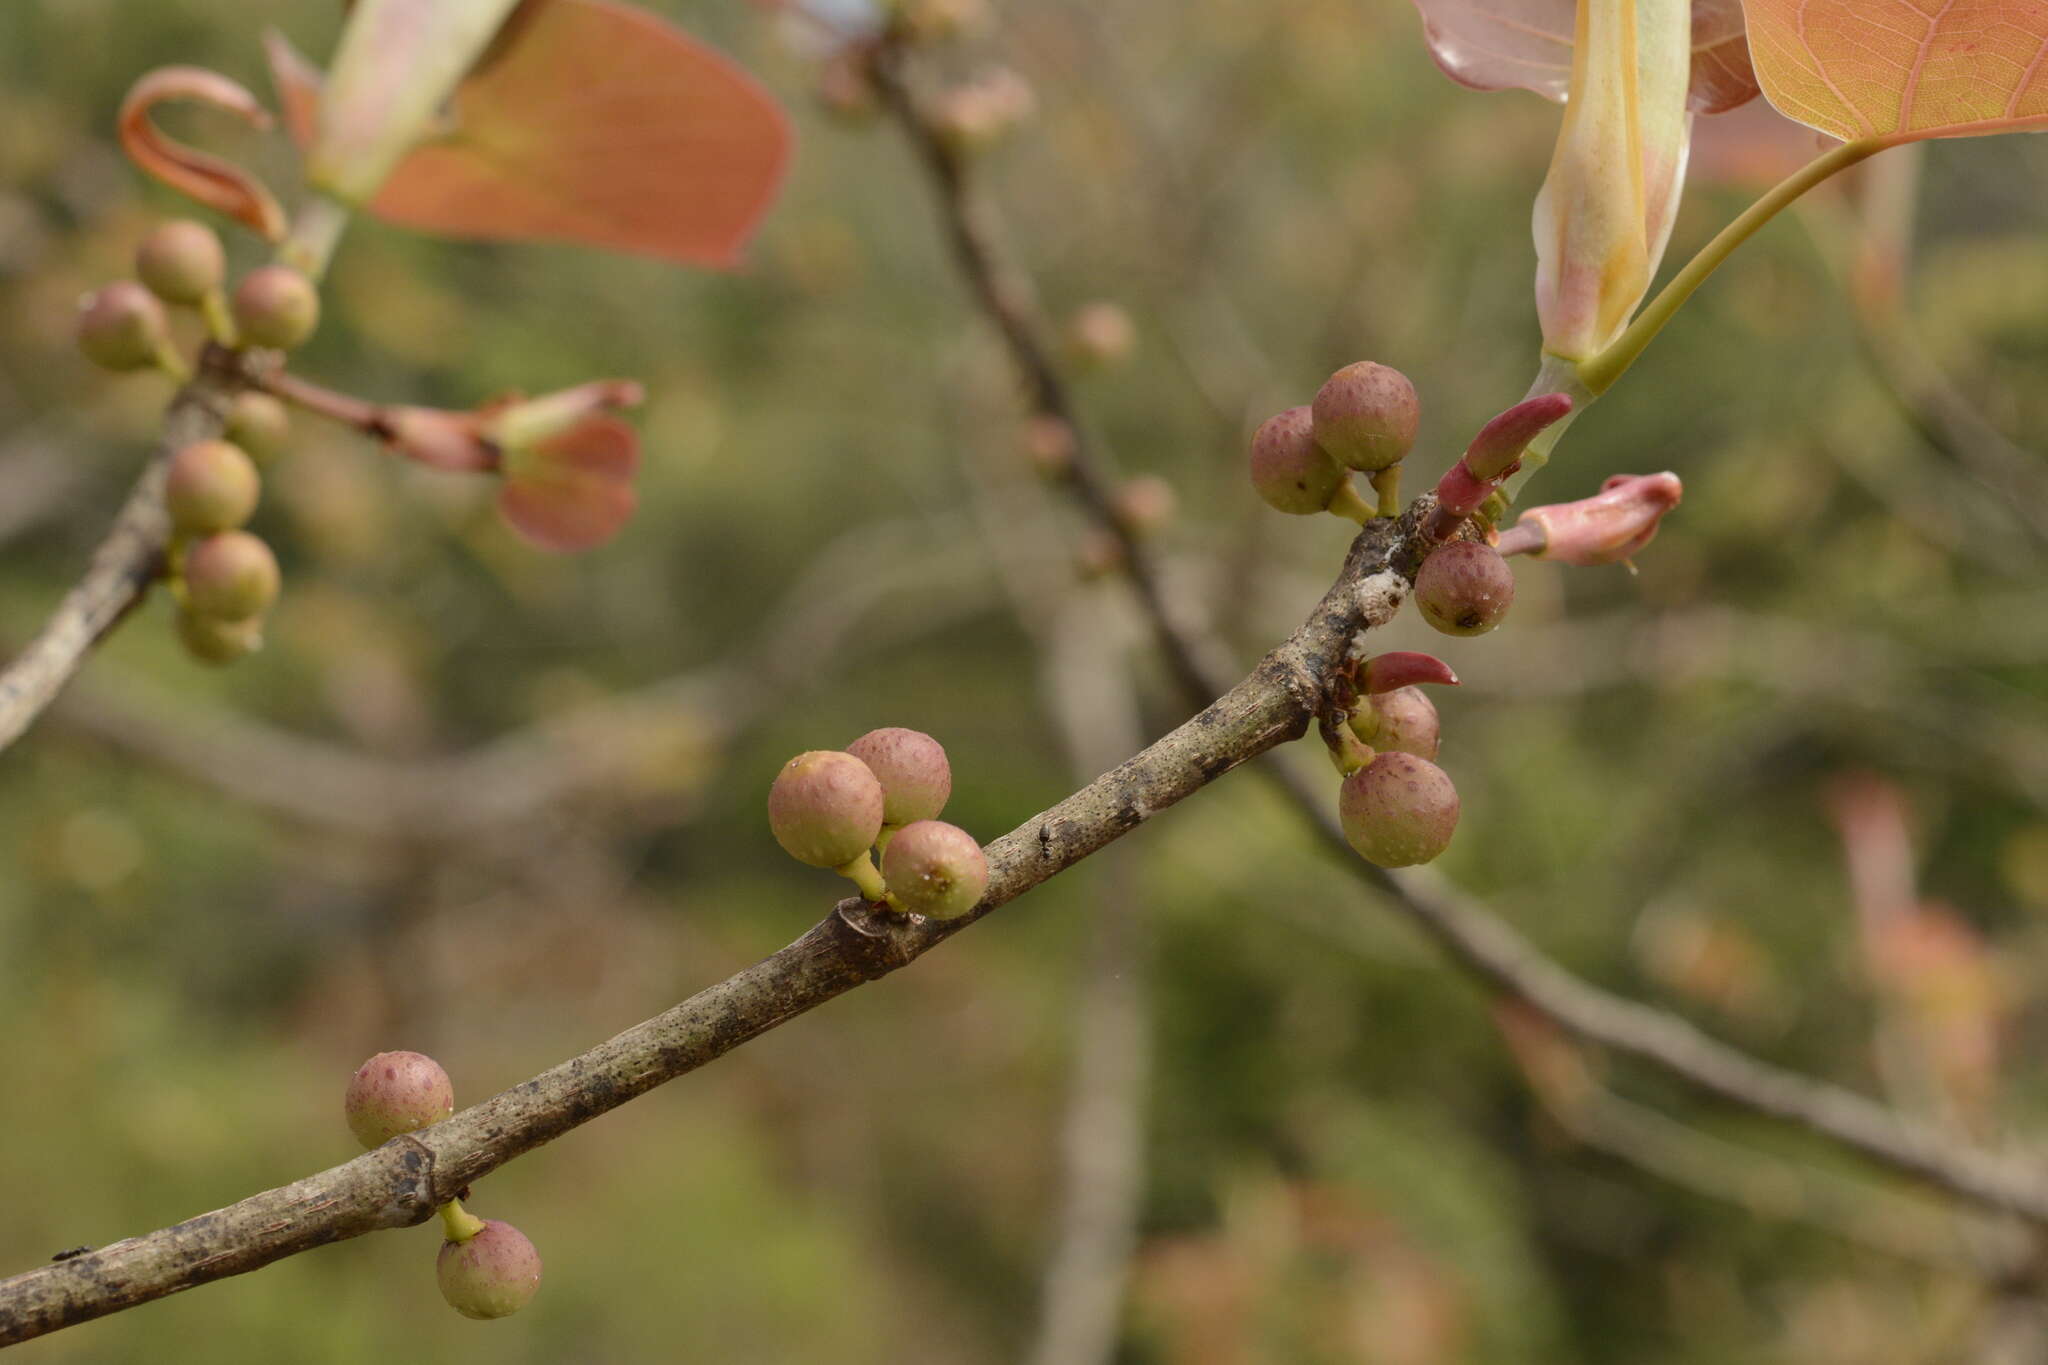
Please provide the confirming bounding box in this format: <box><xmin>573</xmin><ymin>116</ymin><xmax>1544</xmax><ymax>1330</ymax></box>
<box><xmin>342</xmin><ymin>1052</ymin><xmax>541</xmax><ymax>1318</ymax></box>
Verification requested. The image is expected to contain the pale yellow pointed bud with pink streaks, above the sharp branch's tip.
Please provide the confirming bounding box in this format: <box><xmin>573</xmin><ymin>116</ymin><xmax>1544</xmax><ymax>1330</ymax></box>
<box><xmin>1534</xmin><ymin>0</ymin><xmax>1692</xmax><ymax>360</ymax></box>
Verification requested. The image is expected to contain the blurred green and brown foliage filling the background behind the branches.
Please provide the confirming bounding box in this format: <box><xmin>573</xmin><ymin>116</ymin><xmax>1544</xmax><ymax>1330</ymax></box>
<box><xmin>0</xmin><ymin>0</ymin><xmax>2048</xmax><ymax>1365</ymax></box>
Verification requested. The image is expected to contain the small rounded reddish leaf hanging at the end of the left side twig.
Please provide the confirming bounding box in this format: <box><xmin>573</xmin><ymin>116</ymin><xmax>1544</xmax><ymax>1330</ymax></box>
<box><xmin>498</xmin><ymin>415</ymin><xmax>639</xmax><ymax>551</ymax></box>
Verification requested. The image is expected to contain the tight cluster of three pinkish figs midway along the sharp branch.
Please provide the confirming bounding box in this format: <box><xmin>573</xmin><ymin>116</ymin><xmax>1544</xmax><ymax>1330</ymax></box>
<box><xmin>768</xmin><ymin>726</ymin><xmax>989</xmax><ymax>919</ymax></box>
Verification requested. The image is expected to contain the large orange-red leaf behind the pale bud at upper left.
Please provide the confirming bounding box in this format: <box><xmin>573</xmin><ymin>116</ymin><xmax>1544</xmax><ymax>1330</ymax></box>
<box><xmin>270</xmin><ymin>0</ymin><xmax>788</xmax><ymax>266</ymax></box>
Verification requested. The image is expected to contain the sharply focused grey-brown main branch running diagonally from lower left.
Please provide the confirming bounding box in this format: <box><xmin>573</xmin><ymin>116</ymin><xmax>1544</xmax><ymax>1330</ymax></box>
<box><xmin>0</xmin><ymin>503</ymin><xmax>1427</xmax><ymax>1345</ymax></box>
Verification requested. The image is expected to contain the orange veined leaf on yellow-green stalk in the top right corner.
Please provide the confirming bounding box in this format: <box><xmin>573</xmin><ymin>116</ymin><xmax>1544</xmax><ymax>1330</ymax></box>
<box><xmin>1743</xmin><ymin>0</ymin><xmax>2048</xmax><ymax>143</ymax></box>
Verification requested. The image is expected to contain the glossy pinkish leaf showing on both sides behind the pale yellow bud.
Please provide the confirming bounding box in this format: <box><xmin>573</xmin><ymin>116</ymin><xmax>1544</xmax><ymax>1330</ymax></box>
<box><xmin>1415</xmin><ymin>0</ymin><xmax>1757</xmax><ymax>115</ymax></box>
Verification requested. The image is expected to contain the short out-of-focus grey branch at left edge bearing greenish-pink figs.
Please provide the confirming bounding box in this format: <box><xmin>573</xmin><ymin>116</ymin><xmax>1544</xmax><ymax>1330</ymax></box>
<box><xmin>0</xmin><ymin>348</ymin><xmax>246</xmax><ymax>749</ymax></box>
